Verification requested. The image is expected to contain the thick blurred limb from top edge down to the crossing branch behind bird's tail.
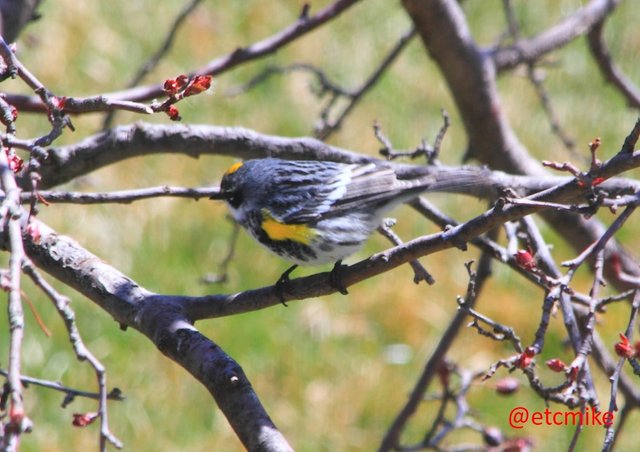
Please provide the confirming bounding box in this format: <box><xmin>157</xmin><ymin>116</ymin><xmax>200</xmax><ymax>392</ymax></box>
<box><xmin>403</xmin><ymin>0</ymin><xmax>544</xmax><ymax>175</ymax></box>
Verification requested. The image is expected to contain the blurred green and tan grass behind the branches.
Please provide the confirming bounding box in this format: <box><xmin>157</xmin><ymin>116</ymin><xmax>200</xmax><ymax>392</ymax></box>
<box><xmin>0</xmin><ymin>0</ymin><xmax>640</xmax><ymax>451</ymax></box>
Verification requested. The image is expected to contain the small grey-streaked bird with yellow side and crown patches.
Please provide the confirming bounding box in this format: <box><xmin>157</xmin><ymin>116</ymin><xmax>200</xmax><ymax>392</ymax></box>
<box><xmin>212</xmin><ymin>158</ymin><xmax>482</xmax><ymax>293</ymax></box>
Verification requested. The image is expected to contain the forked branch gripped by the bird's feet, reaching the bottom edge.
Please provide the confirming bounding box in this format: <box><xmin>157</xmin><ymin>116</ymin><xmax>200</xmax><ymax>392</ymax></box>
<box><xmin>4</xmin><ymin>129</ymin><xmax>640</xmax><ymax>450</ymax></box>
